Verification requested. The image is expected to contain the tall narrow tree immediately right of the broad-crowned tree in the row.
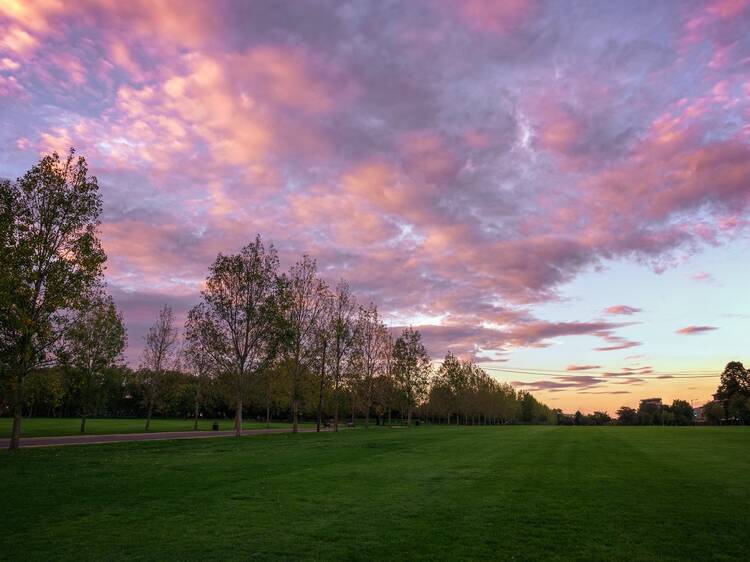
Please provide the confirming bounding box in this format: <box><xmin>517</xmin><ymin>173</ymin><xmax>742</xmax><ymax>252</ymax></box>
<box><xmin>283</xmin><ymin>255</ymin><xmax>328</xmax><ymax>433</ymax></box>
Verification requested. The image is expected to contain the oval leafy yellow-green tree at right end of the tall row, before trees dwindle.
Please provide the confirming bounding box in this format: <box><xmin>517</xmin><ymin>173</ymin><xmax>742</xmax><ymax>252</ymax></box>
<box><xmin>393</xmin><ymin>328</ymin><xmax>430</xmax><ymax>425</ymax></box>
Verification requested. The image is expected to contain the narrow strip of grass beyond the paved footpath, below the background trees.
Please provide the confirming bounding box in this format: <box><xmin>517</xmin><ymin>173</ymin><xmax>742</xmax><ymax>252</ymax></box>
<box><xmin>0</xmin><ymin>418</ymin><xmax>311</xmax><ymax>438</ymax></box>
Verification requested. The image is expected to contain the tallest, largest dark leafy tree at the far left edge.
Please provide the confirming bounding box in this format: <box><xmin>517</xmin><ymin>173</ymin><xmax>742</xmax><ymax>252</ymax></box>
<box><xmin>0</xmin><ymin>150</ymin><xmax>106</xmax><ymax>449</ymax></box>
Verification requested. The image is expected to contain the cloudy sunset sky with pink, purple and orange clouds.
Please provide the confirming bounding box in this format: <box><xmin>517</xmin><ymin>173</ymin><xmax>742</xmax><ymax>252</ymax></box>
<box><xmin>0</xmin><ymin>0</ymin><xmax>750</xmax><ymax>413</ymax></box>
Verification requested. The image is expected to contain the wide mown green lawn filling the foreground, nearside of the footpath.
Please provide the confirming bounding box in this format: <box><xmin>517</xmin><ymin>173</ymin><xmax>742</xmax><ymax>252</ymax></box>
<box><xmin>0</xmin><ymin>426</ymin><xmax>750</xmax><ymax>560</ymax></box>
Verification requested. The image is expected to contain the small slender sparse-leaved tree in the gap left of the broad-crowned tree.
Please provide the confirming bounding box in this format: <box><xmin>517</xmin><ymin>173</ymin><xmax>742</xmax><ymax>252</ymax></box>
<box><xmin>142</xmin><ymin>304</ymin><xmax>177</xmax><ymax>431</ymax></box>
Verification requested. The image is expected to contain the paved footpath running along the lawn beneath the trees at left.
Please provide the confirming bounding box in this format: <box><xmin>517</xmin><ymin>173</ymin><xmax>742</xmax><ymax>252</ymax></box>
<box><xmin>0</xmin><ymin>427</ymin><xmax>329</xmax><ymax>449</ymax></box>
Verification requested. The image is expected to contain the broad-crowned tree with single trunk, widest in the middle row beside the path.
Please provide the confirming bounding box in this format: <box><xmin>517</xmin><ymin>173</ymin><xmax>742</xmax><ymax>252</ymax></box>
<box><xmin>185</xmin><ymin>235</ymin><xmax>280</xmax><ymax>437</ymax></box>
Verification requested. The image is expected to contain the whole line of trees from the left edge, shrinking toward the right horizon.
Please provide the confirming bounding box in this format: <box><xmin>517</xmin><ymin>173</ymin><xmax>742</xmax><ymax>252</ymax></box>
<box><xmin>0</xmin><ymin>150</ymin><xmax>554</xmax><ymax>448</ymax></box>
